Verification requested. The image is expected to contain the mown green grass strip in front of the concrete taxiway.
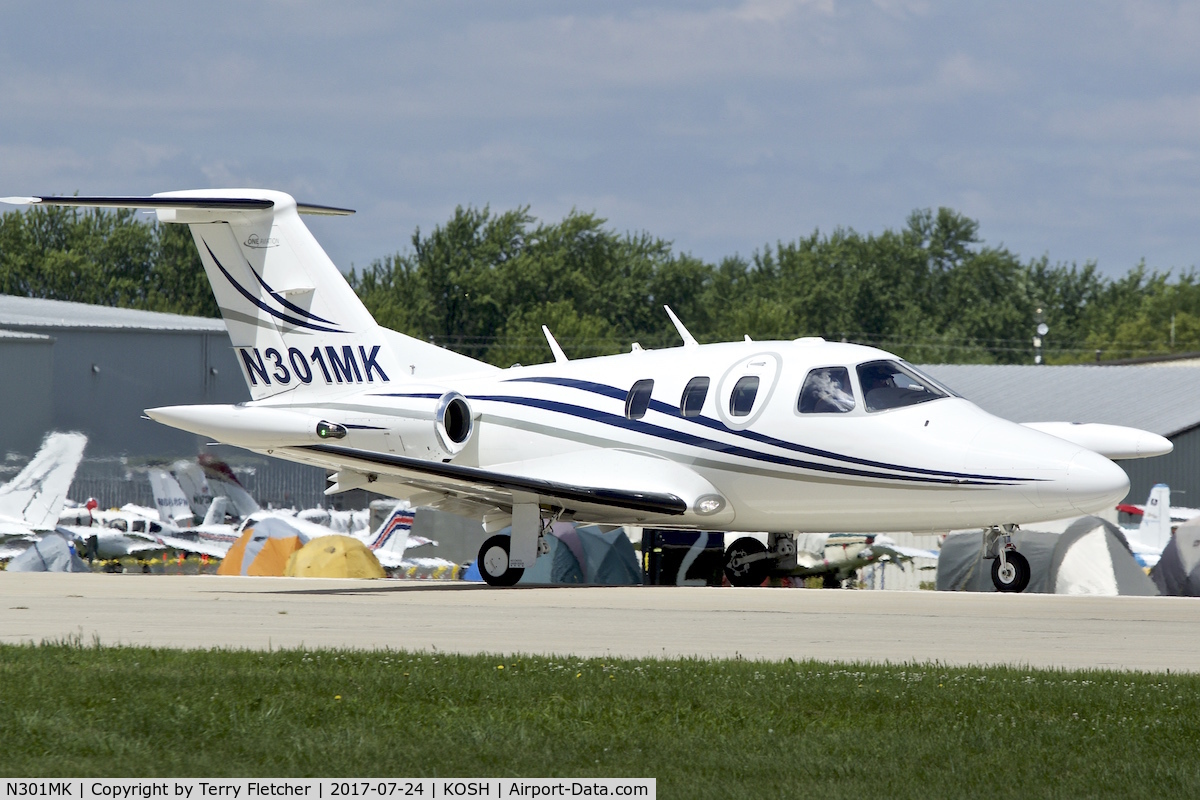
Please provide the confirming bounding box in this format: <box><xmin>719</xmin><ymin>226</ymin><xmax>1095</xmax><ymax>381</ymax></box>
<box><xmin>0</xmin><ymin>643</ymin><xmax>1200</xmax><ymax>798</ymax></box>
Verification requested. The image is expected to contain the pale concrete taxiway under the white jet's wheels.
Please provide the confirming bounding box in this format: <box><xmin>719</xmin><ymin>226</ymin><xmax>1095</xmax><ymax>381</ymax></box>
<box><xmin>0</xmin><ymin>573</ymin><xmax>1200</xmax><ymax>672</ymax></box>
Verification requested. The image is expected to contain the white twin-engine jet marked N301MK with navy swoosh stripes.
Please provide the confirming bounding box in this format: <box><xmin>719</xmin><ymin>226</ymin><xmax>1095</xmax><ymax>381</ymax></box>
<box><xmin>7</xmin><ymin>190</ymin><xmax>1171</xmax><ymax>590</ymax></box>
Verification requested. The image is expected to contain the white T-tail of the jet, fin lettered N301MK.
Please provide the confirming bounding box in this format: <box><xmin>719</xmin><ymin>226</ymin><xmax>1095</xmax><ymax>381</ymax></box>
<box><xmin>4</xmin><ymin>188</ymin><xmax>494</xmax><ymax>403</ymax></box>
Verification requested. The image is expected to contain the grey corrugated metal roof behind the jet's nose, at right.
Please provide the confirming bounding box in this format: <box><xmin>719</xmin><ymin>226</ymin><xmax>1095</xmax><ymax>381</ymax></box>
<box><xmin>920</xmin><ymin>363</ymin><xmax>1200</xmax><ymax>437</ymax></box>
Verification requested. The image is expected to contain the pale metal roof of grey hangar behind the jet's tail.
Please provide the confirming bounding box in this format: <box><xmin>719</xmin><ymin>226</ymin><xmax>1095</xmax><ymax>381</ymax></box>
<box><xmin>0</xmin><ymin>295</ymin><xmax>224</xmax><ymax>331</ymax></box>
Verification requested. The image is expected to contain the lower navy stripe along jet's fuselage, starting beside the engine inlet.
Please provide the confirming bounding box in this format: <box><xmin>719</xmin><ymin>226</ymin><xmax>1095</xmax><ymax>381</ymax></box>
<box><xmin>470</xmin><ymin>395</ymin><xmax>1027</xmax><ymax>486</ymax></box>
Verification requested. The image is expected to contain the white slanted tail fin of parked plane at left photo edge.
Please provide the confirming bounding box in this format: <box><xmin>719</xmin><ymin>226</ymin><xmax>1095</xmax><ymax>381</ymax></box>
<box><xmin>0</xmin><ymin>433</ymin><xmax>88</xmax><ymax>530</ymax></box>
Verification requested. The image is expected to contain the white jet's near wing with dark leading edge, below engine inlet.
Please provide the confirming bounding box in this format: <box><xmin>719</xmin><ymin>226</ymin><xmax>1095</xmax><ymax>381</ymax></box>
<box><xmin>296</xmin><ymin>445</ymin><xmax>696</xmax><ymax>517</ymax></box>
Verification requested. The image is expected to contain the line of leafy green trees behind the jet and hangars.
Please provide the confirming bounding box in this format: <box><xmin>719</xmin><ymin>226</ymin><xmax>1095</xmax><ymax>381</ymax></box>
<box><xmin>0</xmin><ymin>201</ymin><xmax>1200</xmax><ymax>366</ymax></box>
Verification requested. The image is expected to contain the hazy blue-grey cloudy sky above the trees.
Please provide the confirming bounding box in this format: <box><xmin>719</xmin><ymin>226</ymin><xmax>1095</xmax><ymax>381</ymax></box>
<box><xmin>0</xmin><ymin>0</ymin><xmax>1200</xmax><ymax>275</ymax></box>
